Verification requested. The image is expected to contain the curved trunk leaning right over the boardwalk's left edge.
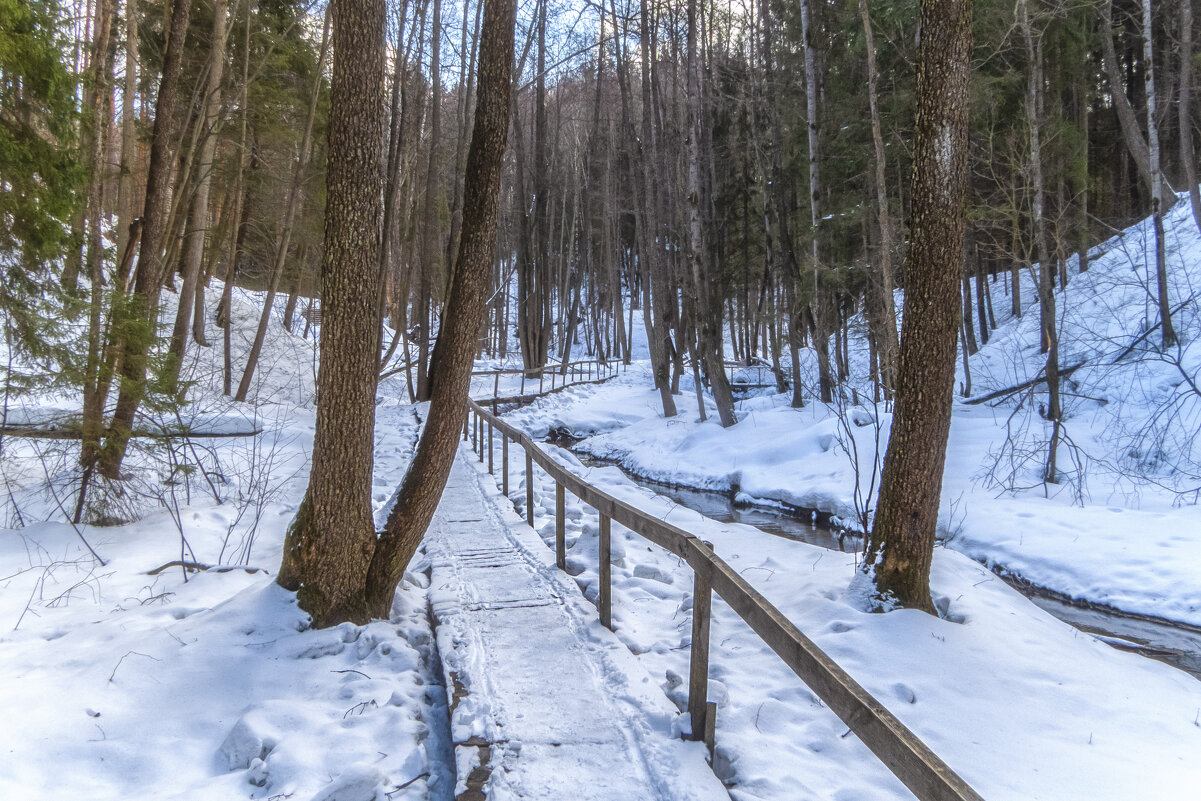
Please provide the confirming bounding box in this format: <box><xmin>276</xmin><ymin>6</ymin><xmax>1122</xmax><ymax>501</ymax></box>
<box><xmin>365</xmin><ymin>0</ymin><xmax>516</xmax><ymax>622</ymax></box>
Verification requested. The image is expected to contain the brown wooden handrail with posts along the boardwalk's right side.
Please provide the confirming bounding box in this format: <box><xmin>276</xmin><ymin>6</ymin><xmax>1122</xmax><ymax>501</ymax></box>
<box><xmin>464</xmin><ymin>401</ymin><xmax>982</xmax><ymax>801</ymax></box>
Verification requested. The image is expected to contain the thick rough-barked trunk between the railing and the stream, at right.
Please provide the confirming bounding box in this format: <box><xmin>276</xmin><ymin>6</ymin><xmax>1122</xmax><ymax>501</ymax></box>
<box><xmin>864</xmin><ymin>0</ymin><xmax>972</xmax><ymax>614</ymax></box>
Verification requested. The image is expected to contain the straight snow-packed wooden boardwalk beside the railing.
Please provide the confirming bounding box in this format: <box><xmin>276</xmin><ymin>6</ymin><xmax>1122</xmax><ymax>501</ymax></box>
<box><xmin>425</xmin><ymin>449</ymin><xmax>729</xmax><ymax>801</ymax></box>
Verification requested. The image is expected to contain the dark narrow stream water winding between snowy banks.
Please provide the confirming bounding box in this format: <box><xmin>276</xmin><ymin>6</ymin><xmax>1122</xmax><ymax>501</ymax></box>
<box><xmin>571</xmin><ymin>449</ymin><xmax>1201</xmax><ymax>680</ymax></box>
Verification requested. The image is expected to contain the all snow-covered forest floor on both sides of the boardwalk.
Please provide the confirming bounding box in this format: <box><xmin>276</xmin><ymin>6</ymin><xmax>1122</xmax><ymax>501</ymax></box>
<box><xmin>0</xmin><ymin>204</ymin><xmax>1201</xmax><ymax>801</ymax></box>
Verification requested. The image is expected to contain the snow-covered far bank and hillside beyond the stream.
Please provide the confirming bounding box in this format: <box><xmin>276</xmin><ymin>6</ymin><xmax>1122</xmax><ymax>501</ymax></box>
<box><xmin>509</xmin><ymin>196</ymin><xmax>1201</xmax><ymax>626</ymax></box>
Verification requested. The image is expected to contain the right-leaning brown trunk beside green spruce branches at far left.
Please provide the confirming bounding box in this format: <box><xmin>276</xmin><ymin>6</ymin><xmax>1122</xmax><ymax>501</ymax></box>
<box><xmin>97</xmin><ymin>0</ymin><xmax>191</xmax><ymax>479</ymax></box>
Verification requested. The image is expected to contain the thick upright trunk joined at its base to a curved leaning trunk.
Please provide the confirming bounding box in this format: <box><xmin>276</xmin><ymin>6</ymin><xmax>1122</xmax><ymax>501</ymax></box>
<box><xmin>277</xmin><ymin>0</ymin><xmax>387</xmax><ymax>627</ymax></box>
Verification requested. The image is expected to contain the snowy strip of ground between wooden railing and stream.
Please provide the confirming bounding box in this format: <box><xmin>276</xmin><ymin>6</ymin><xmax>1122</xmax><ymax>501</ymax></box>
<box><xmin>477</xmin><ymin>439</ymin><xmax>1201</xmax><ymax>801</ymax></box>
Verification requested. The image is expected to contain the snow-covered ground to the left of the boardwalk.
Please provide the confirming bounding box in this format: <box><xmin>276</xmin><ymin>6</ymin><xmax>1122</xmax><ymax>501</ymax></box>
<box><xmin>0</xmin><ymin>284</ymin><xmax>454</xmax><ymax>801</ymax></box>
